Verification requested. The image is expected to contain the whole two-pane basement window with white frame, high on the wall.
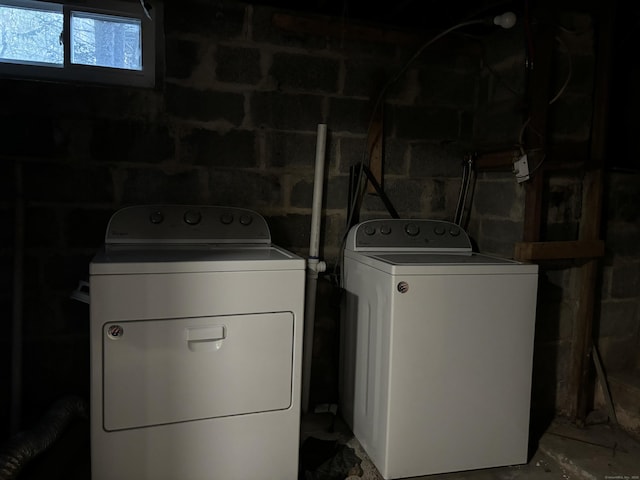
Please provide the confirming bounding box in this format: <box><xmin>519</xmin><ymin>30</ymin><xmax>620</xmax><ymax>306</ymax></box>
<box><xmin>0</xmin><ymin>0</ymin><xmax>158</xmax><ymax>86</ymax></box>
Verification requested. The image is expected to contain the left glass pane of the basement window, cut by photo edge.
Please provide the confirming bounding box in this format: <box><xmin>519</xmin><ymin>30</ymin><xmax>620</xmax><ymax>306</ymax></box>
<box><xmin>0</xmin><ymin>5</ymin><xmax>64</xmax><ymax>65</ymax></box>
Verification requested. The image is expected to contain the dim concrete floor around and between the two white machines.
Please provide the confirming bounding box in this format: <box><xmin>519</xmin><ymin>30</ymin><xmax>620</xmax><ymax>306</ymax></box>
<box><xmin>8</xmin><ymin>413</ymin><xmax>640</xmax><ymax>480</ymax></box>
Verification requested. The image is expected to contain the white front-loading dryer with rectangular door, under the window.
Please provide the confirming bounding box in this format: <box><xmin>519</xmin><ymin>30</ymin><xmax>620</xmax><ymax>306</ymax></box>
<box><xmin>90</xmin><ymin>206</ymin><xmax>305</xmax><ymax>480</ymax></box>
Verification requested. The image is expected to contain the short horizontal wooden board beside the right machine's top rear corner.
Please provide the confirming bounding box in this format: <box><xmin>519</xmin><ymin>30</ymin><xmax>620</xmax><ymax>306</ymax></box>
<box><xmin>514</xmin><ymin>240</ymin><xmax>604</xmax><ymax>261</ymax></box>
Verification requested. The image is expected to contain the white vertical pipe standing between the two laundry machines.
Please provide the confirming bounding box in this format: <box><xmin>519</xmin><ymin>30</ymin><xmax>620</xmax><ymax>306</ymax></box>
<box><xmin>302</xmin><ymin>123</ymin><xmax>327</xmax><ymax>413</ymax></box>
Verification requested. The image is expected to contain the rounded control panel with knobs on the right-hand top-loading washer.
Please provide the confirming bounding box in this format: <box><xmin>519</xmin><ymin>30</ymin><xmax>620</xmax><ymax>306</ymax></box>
<box><xmin>346</xmin><ymin>219</ymin><xmax>472</xmax><ymax>252</ymax></box>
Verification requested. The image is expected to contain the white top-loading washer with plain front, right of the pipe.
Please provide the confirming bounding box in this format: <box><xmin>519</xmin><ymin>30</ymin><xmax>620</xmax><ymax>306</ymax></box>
<box><xmin>340</xmin><ymin>219</ymin><xmax>538</xmax><ymax>479</ymax></box>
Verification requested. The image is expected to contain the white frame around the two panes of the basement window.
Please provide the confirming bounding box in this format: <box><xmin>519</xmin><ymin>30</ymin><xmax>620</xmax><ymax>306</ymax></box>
<box><xmin>0</xmin><ymin>0</ymin><xmax>161</xmax><ymax>87</ymax></box>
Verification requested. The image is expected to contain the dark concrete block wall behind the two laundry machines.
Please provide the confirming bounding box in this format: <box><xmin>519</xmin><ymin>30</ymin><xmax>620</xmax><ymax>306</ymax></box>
<box><xmin>0</xmin><ymin>0</ymin><xmax>638</xmax><ymax>436</ymax></box>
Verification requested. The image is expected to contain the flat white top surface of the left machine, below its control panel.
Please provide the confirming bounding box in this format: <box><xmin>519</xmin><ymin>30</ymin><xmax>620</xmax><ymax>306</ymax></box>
<box><xmin>89</xmin><ymin>245</ymin><xmax>305</xmax><ymax>275</ymax></box>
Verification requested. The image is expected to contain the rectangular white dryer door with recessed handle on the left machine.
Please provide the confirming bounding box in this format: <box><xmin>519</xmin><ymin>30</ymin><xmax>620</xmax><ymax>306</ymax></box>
<box><xmin>102</xmin><ymin>312</ymin><xmax>294</xmax><ymax>430</ymax></box>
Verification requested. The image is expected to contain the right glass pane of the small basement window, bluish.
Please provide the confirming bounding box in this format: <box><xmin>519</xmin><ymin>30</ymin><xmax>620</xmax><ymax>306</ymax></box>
<box><xmin>71</xmin><ymin>12</ymin><xmax>142</xmax><ymax>70</ymax></box>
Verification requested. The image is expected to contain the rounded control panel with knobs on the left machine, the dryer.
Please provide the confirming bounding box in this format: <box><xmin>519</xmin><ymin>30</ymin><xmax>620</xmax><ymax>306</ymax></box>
<box><xmin>105</xmin><ymin>205</ymin><xmax>271</xmax><ymax>245</ymax></box>
